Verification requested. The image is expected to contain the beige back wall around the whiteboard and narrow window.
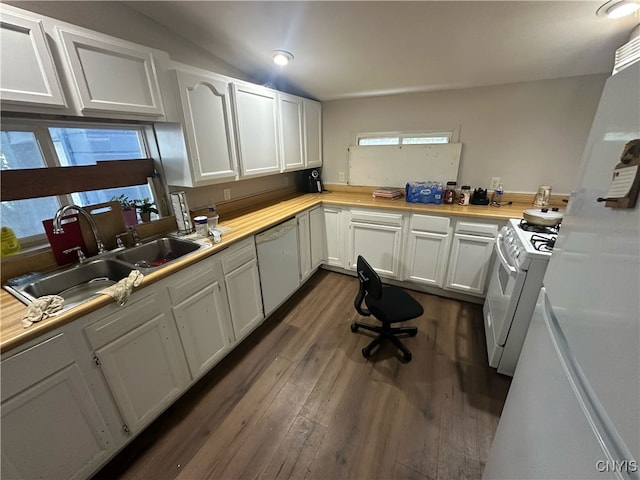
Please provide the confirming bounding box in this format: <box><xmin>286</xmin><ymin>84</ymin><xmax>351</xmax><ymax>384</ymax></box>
<box><xmin>322</xmin><ymin>75</ymin><xmax>606</xmax><ymax>193</ymax></box>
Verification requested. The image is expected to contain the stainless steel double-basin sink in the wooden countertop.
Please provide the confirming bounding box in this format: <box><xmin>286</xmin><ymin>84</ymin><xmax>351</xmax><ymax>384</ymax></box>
<box><xmin>4</xmin><ymin>236</ymin><xmax>211</xmax><ymax>311</ymax></box>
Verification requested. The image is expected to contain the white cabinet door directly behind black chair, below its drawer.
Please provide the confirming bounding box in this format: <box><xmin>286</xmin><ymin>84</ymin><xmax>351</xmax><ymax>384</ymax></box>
<box><xmin>348</xmin><ymin>222</ymin><xmax>402</xmax><ymax>277</ymax></box>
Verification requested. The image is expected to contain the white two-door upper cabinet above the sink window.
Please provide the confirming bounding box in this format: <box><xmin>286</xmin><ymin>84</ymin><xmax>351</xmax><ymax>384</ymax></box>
<box><xmin>0</xmin><ymin>4</ymin><xmax>168</xmax><ymax>120</ymax></box>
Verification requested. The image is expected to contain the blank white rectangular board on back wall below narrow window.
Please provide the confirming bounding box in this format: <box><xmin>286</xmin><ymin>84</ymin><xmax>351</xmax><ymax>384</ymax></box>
<box><xmin>348</xmin><ymin>143</ymin><xmax>462</xmax><ymax>187</ymax></box>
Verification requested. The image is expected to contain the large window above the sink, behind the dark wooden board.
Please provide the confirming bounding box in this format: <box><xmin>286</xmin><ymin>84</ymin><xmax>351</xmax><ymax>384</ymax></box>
<box><xmin>0</xmin><ymin>123</ymin><xmax>153</xmax><ymax>245</ymax></box>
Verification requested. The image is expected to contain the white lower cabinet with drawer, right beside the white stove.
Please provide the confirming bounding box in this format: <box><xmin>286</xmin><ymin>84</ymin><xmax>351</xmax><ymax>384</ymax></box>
<box><xmin>445</xmin><ymin>221</ymin><xmax>498</xmax><ymax>295</ymax></box>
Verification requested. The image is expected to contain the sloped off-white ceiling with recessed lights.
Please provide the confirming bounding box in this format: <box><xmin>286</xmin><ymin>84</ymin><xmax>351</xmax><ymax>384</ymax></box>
<box><xmin>124</xmin><ymin>0</ymin><xmax>640</xmax><ymax>100</ymax></box>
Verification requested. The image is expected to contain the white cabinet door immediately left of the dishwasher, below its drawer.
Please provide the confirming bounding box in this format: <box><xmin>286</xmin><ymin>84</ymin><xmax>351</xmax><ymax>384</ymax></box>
<box><xmin>225</xmin><ymin>259</ymin><xmax>264</xmax><ymax>342</ymax></box>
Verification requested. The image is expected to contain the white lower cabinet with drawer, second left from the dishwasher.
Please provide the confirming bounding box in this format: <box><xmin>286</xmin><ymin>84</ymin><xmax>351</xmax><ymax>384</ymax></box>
<box><xmin>169</xmin><ymin>256</ymin><xmax>234</xmax><ymax>379</ymax></box>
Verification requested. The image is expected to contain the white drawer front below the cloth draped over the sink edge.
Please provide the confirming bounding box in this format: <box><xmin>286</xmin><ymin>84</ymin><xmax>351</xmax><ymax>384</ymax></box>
<box><xmin>84</xmin><ymin>293</ymin><xmax>162</xmax><ymax>348</ymax></box>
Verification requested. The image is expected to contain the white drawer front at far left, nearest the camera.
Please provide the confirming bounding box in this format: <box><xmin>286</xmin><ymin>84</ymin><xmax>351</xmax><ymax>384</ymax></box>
<box><xmin>2</xmin><ymin>333</ymin><xmax>74</xmax><ymax>402</ymax></box>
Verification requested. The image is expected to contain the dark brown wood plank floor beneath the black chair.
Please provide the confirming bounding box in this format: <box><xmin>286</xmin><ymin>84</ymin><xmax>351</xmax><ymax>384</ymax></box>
<box><xmin>96</xmin><ymin>271</ymin><xmax>510</xmax><ymax>480</ymax></box>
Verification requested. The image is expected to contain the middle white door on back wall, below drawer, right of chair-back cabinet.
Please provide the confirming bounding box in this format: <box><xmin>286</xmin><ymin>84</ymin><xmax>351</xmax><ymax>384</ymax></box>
<box><xmin>407</xmin><ymin>232</ymin><xmax>451</xmax><ymax>287</ymax></box>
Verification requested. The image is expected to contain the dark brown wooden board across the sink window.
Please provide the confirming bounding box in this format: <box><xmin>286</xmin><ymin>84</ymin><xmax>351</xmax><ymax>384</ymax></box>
<box><xmin>0</xmin><ymin>158</ymin><xmax>154</xmax><ymax>201</ymax></box>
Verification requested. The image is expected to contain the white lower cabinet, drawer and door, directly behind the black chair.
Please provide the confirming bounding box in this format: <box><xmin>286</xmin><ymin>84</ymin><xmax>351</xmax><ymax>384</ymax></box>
<box><xmin>347</xmin><ymin>210</ymin><xmax>403</xmax><ymax>278</ymax></box>
